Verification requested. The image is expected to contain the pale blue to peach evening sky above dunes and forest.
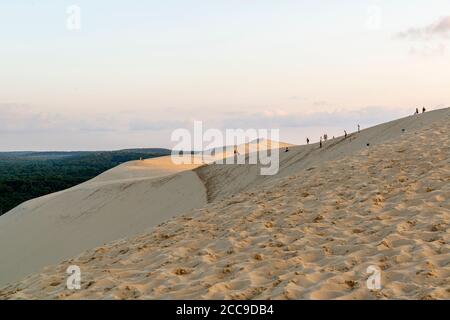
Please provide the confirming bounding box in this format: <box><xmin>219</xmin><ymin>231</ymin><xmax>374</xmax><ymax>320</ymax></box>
<box><xmin>0</xmin><ymin>0</ymin><xmax>450</xmax><ymax>151</ymax></box>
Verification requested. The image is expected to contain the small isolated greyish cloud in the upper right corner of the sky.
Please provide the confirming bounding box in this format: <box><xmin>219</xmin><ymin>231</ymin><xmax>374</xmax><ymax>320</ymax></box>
<box><xmin>395</xmin><ymin>16</ymin><xmax>450</xmax><ymax>40</ymax></box>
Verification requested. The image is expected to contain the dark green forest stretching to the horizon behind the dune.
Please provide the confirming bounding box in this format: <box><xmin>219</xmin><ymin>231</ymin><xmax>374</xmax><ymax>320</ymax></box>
<box><xmin>0</xmin><ymin>148</ymin><xmax>170</xmax><ymax>215</ymax></box>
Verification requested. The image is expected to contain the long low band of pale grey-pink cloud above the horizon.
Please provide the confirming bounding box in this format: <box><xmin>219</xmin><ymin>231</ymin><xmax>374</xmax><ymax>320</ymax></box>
<box><xmin>0</xmin><ymin>103</ymin><xmax>432</xmax><ymax>134</ymax></box>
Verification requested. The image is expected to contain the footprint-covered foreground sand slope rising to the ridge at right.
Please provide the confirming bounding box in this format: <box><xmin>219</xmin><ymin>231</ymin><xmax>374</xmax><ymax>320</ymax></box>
<box><xmin>0</xmin><ymin>109</ymin><xmax>450</xmax><ymax>299</ymax></box>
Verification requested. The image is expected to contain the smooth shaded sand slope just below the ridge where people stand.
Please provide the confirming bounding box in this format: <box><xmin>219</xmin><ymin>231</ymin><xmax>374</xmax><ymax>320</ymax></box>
<box><xmin>195</xmin><ymin>108</ymin><xmax>450</xmax><ymax>201</ymax></box>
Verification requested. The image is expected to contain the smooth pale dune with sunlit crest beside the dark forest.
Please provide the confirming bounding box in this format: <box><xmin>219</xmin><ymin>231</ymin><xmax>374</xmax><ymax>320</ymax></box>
<box><xmin>0</xmin><ymin>140</ymin><xmax>287</xmax><ymax>285</ymax></box>
